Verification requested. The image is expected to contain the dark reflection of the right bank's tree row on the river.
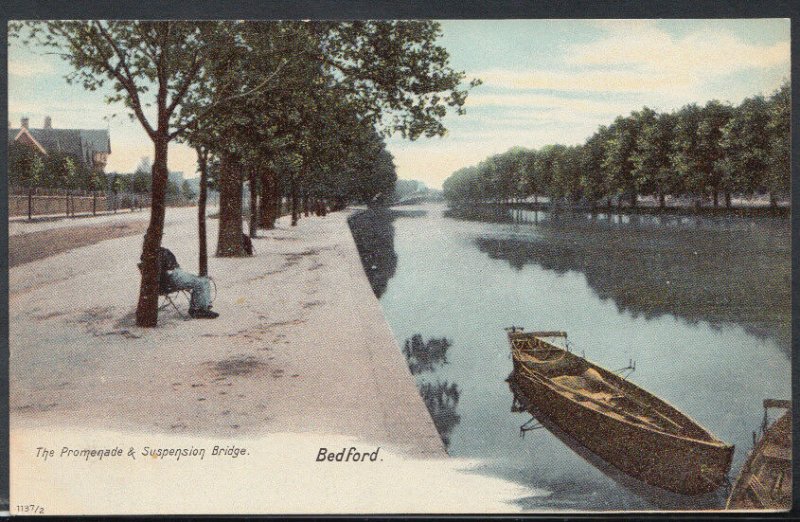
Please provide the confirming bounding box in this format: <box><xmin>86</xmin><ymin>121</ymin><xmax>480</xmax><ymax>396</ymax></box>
<box><xmin>460</xmin><ymin>205</ymin><xmax>791</xmax><ymax>354</ymax></box>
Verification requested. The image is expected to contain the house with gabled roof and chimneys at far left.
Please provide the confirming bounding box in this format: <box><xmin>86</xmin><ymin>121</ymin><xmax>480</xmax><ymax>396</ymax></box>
<box><xmin>8</xmin><ymin>116</ymin><xmax>111</xmax><ymax>172</ymax></box>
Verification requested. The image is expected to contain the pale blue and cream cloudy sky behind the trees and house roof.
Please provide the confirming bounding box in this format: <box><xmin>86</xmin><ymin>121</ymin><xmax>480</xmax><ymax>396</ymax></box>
<box><xmin>8</xmin><ymin>19</ymin><xmax>790</xmax><ymax>188</ymax></box>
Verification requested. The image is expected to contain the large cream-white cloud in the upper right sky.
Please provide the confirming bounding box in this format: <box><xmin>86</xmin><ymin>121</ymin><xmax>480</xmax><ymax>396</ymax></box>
<box><xmin>476</xmin><ymin>20</ymin><xmax>791</xmax><ymax>98</ymax></box>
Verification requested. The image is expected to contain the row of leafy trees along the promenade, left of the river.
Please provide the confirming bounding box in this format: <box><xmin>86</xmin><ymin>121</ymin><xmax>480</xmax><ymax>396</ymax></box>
<box><xmin>9</xmin><ymin>20</ymin><xmax>479</xmax><ymax>326</ymax></box>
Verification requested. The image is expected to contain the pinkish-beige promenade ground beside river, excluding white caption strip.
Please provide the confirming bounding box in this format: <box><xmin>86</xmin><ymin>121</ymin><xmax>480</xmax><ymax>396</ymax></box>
<box><xmin>10</xmin><ymin>204</ymin><xmax>444</xmax><ymax>456</ymax></box>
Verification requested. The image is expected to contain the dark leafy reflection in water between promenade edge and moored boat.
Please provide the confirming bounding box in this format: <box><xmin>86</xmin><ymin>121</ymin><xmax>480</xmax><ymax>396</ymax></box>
<box><xmin>403</xmin><ymin>334</ymin><xmax>461</xmax><ymax>448</ymax></box>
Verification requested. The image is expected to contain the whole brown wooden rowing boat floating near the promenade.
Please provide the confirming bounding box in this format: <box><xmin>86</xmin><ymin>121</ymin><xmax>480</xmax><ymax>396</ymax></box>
<box><xmin>508</xmin><ymin>330</ymin><xmax>734</xmax><ymax>495</ymax></box>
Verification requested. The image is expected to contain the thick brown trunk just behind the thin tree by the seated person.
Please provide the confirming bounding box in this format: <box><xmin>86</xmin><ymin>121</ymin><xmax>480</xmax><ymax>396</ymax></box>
<box><xmin>217</xmin><ymin>152</ymin><xmax>246</xmax><ymax>257</ymax></box>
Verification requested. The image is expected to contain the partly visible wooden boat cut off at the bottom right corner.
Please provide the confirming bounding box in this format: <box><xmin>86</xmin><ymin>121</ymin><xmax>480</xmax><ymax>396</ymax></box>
<box><xmin>726</xmin><ymin>399</ymin><xmax>792</xmax><ymax>511</ymax></box>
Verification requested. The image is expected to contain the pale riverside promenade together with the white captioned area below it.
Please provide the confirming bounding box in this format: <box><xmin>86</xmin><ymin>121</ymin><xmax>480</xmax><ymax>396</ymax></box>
<box><xmin>9</xmin><ymin>209</ymin><xmax>531</xmax><ymax>514</ymax></box>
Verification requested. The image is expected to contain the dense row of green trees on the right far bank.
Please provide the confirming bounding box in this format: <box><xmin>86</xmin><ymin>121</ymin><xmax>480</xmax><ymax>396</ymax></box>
<box><xmin>443</xmin><ymin>82</ymin><xmax>791</xmax><ymax>208</ymax></box>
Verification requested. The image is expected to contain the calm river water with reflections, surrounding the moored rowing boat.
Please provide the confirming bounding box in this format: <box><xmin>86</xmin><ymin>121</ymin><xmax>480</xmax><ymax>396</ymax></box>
<box><xmin>352</xmin><ymin>204</ymin><xmax>791</xmax><ymax>510</ymax></box>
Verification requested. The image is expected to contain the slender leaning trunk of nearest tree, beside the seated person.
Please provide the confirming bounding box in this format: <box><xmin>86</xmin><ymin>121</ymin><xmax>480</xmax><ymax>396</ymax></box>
<box><xmin>136</xmin><ymin>132</ymin><xmax>169</xmax><ymax>327</ymax></box>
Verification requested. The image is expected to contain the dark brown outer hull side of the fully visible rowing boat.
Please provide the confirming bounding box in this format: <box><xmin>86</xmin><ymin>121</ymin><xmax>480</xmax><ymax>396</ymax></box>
<box><xmin>515</xmin><ymin>362</ymin><xmax>733</xmax><ymax>495</ymax></box>
